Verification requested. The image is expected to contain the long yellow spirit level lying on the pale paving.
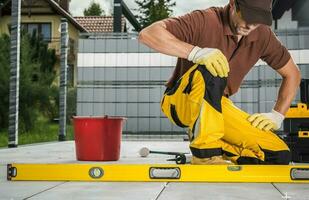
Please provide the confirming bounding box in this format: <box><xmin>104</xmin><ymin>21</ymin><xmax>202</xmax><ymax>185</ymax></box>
<box><xmin>7</xmin><ymin>164</ymin><xmax>309</xmax><ymax>183</ymax></box>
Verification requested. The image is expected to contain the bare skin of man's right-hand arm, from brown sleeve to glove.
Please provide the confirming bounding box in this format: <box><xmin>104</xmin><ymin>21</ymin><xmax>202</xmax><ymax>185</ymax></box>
<box><xmin>274</xmin><ymin>58</ymin><xmax>301</xmax><ymax>115</ymax></box>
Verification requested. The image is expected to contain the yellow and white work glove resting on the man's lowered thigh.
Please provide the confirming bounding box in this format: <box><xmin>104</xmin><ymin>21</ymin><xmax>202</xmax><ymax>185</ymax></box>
<box><xmin>248</xmin><ymin>109</ymin><xmax>284</xmax><ymax>131</ymax></box>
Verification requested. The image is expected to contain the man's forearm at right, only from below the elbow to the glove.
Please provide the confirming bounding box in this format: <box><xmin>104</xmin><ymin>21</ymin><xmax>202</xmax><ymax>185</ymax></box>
<box><xmin>274</xmin><ymin>77</ymin><xmax>300</xmax><ymax>115</ymax></box>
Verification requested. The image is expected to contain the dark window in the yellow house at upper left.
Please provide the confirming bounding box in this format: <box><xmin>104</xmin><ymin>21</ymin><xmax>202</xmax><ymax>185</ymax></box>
<box><xmin>21</xmin><ymin>23</ymin><xmax>51</xmax><ymax>42</ymax></box>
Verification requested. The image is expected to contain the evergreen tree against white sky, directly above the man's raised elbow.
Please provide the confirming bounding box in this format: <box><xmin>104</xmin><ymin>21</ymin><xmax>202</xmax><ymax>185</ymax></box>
<box><xmin>135</xmin><ymin>0</ymin><xmax>176</xmax><ymax>27</ymax></box>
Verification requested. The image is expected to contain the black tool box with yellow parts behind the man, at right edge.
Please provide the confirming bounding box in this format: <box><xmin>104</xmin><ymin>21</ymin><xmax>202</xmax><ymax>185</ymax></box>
<box><xmin>282</xmin><ymin>79</ymin><xmax>309</xmax><ymax>163</ymax></box>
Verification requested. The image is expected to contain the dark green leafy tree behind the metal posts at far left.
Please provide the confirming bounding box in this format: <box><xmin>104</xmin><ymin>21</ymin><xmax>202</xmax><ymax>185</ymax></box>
<box><xmin>0</xmin><ymin>34</ymin><xmax>59</xmax><ymax>133</ymax></box>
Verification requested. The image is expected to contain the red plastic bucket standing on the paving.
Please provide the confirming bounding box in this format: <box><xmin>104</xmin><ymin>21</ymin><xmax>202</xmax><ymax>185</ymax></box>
<box><xmin>73</xmin><ymin>116</ymin><xmax>126</xmax><ymax>161</ymax></box>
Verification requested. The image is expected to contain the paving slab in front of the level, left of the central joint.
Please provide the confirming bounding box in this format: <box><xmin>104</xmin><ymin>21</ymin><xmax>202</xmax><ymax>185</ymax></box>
<box><xmin>26</xmin><ymin>182</ymin><xmax>164</xmax><ymax>200</ymax></box>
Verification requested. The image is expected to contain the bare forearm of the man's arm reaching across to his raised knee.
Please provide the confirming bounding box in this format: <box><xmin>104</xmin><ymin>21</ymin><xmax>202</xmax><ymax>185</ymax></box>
<box><xmin>139</xmin><ymin>21</ymin><xmax>194</xmax><ymax>59</ymax></box>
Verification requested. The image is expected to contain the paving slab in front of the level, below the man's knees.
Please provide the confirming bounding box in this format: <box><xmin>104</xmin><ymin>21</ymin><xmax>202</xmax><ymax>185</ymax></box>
<box><xmin>158</xmin><ymin>183</ymin><xmax>282</xmax><ymax>200</ymax></box>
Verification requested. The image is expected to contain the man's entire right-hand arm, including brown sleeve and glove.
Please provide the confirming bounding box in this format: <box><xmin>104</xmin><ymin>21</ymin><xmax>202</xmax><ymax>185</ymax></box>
<box><xmin>248</xmin><ymin>27</ymin><xmax>301</xmax><ymax>131</ymax></box>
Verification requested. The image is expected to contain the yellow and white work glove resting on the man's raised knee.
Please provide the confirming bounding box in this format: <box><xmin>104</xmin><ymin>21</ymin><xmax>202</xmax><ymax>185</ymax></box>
<box><xmin>188</xmin><ymin>46</ymin><xmax>230</xmax><ymax>78</ymax></box>
